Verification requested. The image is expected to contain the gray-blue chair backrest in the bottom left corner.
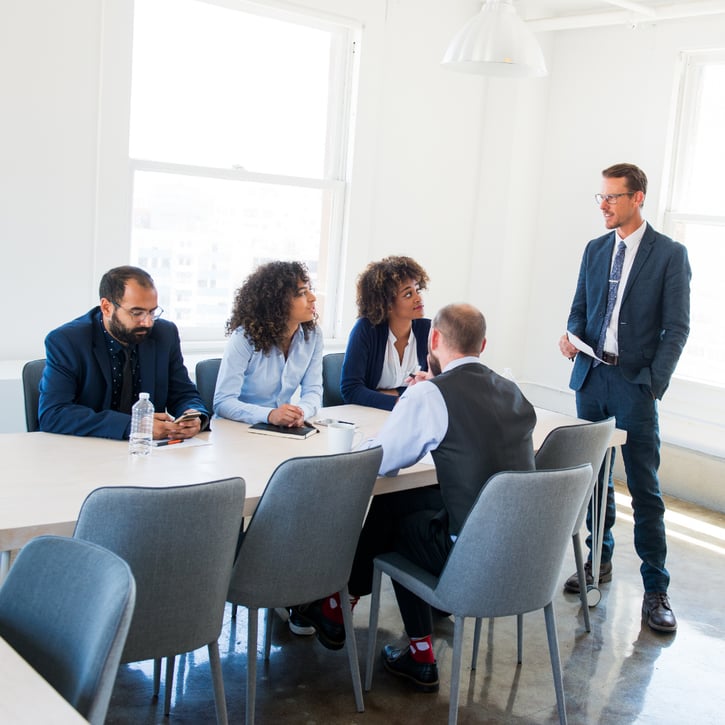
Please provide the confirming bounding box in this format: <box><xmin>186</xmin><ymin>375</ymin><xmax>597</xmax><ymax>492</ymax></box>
<box><xmin>0</xmin><ymin>536</ymin><xmax>136</xmax><ymax>725</ymax></box>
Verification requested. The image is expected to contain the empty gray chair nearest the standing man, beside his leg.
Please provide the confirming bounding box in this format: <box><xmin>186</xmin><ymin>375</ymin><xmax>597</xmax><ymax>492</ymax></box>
<box><xmin>535</xmin><ymin>418</ymin><xmax>615</xmax><ymax>532</ymax></box>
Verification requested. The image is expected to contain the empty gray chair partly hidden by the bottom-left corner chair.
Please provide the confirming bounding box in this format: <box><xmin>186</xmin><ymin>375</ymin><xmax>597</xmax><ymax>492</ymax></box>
<box><xmin>73</xmin><ymin>478</ymin><xmax>245</xmax><ymax>723</ymax></box>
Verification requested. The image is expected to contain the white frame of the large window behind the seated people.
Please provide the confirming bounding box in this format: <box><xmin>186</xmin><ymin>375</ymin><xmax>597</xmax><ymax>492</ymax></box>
<box><xmin>92</xmin><ymin>0</ymin><xmax>362</xmax><ymax>347</ymax></box>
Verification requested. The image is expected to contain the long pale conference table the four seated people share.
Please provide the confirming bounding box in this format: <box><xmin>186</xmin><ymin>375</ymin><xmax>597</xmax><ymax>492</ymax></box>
<box><xmin>0</xmin><ymin>405</ymin><xmax>624</xmax><ymax>581</ymax></box>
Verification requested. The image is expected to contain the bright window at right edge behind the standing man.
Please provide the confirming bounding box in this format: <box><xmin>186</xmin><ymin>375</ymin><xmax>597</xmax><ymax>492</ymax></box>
<box><xmin>665</xmin><ymin>51</ymin><xmax>725</xmax><ymax>386</ymax></box>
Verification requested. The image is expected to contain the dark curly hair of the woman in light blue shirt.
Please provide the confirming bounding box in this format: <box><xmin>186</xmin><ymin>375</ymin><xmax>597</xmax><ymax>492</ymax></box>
<box><xmin>226</xmin><ymin>261</ymin><xmax>317</xmax><ymax>353</ymax></box>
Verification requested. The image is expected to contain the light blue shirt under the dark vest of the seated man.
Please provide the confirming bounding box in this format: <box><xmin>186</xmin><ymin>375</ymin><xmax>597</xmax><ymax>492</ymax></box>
<box><xmin>360</xmin><ymin>356</ymin><xmax>481</xmax><ymax>476</ymax></box>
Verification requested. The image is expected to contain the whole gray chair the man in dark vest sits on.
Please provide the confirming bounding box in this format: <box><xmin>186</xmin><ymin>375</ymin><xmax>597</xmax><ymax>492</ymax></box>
<box><xmin>365</xmin><ymin>464</ymin><xmax>592</xmax><ymax>724</ymax></box>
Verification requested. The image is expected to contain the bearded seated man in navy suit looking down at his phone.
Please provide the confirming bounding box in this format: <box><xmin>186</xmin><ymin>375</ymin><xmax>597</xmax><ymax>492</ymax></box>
<box><xmin>38</xmin><ymin>266</ymin><xmax>209</xmax><ymax>439</ymax></box>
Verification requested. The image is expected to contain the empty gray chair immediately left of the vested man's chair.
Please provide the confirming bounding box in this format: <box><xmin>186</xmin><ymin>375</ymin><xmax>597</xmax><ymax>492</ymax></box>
<box><xmin>228</xmin><ymin>447</ymin><xmax>383</xmax><ymax>725</ymax></box>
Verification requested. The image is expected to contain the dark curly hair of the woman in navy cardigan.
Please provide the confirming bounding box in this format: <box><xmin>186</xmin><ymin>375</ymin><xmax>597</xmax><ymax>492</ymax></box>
<box><xmin>357</xmin><ymin>257</ymin><xmax>428</xmax><ymax>325</ymax></box>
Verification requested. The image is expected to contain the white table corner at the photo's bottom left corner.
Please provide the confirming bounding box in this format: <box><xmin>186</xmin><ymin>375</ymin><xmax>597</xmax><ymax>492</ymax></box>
<box><xmin>0</xmin><ymin>637</ymin><xmax>88</xmax><ymax>725</ymax></box>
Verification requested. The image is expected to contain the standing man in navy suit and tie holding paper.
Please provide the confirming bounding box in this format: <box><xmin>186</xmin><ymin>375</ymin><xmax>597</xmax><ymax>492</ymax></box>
<box><xmin>559</xmin><ymin>164</ymin><xmax>691</xmax><ymax>632</ymax></box>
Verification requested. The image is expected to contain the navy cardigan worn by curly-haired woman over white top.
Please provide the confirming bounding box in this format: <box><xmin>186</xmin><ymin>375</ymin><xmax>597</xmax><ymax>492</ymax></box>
<box><xmin>340</xmin><ymin>317</ymin><xmax>430</xmax><ymax>410</ymax></box>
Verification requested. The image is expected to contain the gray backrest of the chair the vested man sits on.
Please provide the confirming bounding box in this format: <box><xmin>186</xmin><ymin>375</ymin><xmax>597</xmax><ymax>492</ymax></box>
<box><xmin>436</xmin><ymin>464</ymin><xmax>592</xmax><ymax>617</ymax></box>
